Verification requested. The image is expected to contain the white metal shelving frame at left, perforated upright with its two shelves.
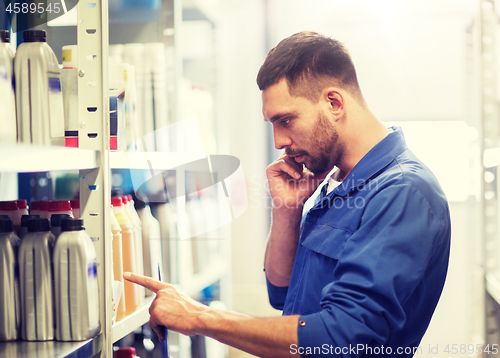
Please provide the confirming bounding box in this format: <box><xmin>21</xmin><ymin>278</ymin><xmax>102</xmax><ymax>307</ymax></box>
<box><xmin>0</xmin><ymin>0</ymin><xmax>109</xmax><ymax>358</ymax></box>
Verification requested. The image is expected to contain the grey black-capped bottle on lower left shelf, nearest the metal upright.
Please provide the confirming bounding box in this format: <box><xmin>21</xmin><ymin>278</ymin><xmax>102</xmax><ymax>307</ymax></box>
<box><xmin>54</xmin><ymin>218</ymin><xmax>101</xmax><ymax>341</ymax></box>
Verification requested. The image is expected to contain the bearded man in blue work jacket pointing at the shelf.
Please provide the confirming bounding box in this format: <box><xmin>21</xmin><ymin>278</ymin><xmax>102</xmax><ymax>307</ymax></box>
<box><xmin>124</xmin><ymin>32</ymin><xmax>450</xmax><ymax>357</ymax></box>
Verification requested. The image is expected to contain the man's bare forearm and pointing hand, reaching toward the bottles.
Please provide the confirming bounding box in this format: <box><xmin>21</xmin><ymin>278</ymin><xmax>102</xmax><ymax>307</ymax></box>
<box><xmin>123</xmin><ymin>272</ymin><xmax>299</xmax><ymax>358</ymax></box>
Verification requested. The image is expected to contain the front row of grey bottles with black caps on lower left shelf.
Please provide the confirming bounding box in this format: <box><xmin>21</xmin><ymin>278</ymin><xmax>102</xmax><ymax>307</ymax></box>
<box><xmin>0</xmin><ymin>213</ymin><xmax>100</xmax><ymax>341</ymax></box>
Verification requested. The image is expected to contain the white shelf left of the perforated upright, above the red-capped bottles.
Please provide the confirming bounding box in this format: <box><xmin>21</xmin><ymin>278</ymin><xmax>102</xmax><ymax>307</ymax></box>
<box><xmin>0</xmin><ymin>144</ymin><xmax>98</xmax><ymax>173</ymax></box>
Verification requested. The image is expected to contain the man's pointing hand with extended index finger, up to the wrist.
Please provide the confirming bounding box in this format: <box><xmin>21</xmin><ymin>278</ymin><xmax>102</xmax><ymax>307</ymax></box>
<box><xmin>123</xmin><ymin>272</ymin><xmax>211</xmax><ymax>342</ymax></box>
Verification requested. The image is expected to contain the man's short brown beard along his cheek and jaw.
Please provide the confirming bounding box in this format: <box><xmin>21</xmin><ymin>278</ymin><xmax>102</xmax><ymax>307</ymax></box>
<box><xmin>287</xmin><ymin>111</ymin><xmax>342</xmax><ymax>174</ymax></box>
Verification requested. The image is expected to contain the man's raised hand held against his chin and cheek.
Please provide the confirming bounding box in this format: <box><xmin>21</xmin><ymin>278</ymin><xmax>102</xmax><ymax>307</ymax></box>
<box><xmin>266</xmin><ymin>154</ymin><xmax>328</xmax><ymax>209</ymax></box>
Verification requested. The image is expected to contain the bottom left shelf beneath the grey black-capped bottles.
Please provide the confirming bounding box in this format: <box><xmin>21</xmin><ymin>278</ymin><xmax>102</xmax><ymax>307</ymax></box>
<box><xmin>0</xmin><ymin>333</ymin><xmax>102</xmax><ymax>358</ymax></box>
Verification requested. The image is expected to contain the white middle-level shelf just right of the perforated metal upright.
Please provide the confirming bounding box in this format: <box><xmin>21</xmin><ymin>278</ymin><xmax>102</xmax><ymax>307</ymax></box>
<box><xmin>109</xmin><ymin>152</ymin><xmax>206</xmax><ymax>170</ymax></box>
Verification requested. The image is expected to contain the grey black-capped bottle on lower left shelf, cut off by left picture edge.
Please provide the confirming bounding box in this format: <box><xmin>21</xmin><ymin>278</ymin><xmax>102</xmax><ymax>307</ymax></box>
<box><xmin>0</xmin><ymin>219</ymin><xmax>21</xmax><ymax>341</ymax></box>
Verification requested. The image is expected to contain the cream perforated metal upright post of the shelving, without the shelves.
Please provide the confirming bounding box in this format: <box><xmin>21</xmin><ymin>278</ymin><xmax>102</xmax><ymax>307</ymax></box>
<box><xmin>77</xmin><ymin>0</ymin><xmax>113</xmax><ymax>357</ymax></box>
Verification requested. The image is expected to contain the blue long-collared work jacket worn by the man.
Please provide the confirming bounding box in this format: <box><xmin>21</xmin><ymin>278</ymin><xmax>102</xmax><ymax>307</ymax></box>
<box><xmin>268</xmin><ymin>127</ymin><xmax>451</xmax><ymax>357</ymax></box>
